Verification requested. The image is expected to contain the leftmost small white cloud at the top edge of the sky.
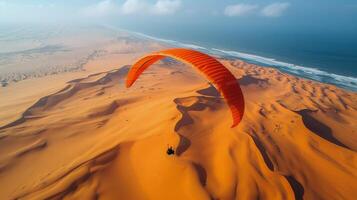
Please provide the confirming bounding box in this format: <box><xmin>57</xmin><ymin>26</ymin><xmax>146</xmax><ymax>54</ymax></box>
<box><xmin>82</xmin><ymin>0</ymin><xmax>119</xmax><ymax>17</ymax></box>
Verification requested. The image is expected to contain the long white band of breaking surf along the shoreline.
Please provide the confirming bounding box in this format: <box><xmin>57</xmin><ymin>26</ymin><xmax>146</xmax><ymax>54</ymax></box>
<box><xmin>131</xmin><ymin>29</ymin><xmax>357</xmax><ymax>91</ymax></box>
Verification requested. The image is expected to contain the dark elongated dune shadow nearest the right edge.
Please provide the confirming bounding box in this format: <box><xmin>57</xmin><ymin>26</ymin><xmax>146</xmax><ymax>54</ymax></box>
<box><xmin>296</xmin><ymin>109</ymin><xmax>350</xmax><ymax>149</ymax></box>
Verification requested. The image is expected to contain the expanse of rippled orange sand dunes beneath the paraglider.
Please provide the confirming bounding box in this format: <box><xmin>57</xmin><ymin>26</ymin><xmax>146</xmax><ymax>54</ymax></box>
<box><xmin>0</xmin><ymin>59</ymin><xmax>357</xmax><ymax>199</ymax></box>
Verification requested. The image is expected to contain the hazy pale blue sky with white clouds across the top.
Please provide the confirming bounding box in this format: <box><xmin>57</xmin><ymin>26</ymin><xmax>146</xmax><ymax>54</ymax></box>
<box><xmin>0</xmin><ymin>0</ymin><xmax>357</xmax><ymax>32</ymax></box>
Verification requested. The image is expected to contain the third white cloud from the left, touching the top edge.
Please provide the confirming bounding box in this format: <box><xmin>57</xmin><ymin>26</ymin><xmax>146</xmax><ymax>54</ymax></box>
<box><xmin>151</xmin><ymin>0</ymin><xmax>181</xmax><ymax>15</ymax></box>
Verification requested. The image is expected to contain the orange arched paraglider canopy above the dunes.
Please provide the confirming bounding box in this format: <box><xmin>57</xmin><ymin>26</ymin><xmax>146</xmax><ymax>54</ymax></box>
<box><xmin>126</xmin><ymin>48</ymin><xmax>244</xmax><ymax>127</ymax></box>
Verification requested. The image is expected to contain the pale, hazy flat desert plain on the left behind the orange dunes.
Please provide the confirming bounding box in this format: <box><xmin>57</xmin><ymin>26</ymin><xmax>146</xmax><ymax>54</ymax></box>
<box><xmin>0</xmin><ymin>26</ymin><xmax>164</xmax><ymax>126</ymax></box>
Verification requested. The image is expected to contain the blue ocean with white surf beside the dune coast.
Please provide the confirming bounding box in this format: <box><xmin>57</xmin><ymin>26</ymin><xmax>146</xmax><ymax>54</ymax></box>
<box><xmin>128</xmin><ymin>32</ymin><xmax>357</xmax><ymax>92</ymax></box>
